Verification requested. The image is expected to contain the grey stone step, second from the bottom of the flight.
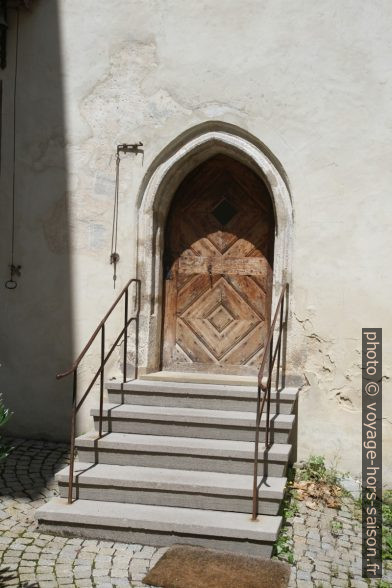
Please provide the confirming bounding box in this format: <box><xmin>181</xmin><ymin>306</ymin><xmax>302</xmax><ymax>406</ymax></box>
<box><xmin>56</xmin><ymin>462</ymin><xmax>286</xmax><ymax>515</ymax></box>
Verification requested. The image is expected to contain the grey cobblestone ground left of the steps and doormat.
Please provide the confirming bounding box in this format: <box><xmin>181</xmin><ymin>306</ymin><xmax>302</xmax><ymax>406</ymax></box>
<box><xmin>0</xmin><ymin>439</ymin><xmax>165</xmax><ymax>588</ymax></box>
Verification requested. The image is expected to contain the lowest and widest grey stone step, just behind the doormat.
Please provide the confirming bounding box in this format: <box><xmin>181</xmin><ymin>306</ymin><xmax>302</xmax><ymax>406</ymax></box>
<box><xmin>35</xmin><ymin>498</ymin><xmax>282</xmax><ymax>557</ymax></box>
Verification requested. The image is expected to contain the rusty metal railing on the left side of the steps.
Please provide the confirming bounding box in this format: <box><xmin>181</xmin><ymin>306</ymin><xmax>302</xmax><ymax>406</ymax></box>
<box><xmin>56</xmin><ymin>278</ymin><xmax>141</xmax><ymax>504</ymax></box>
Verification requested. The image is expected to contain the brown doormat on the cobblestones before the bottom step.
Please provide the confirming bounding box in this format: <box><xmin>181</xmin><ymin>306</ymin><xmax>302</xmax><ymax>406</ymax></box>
<box><xmin>143</xmin><ymin>545</ymin><xmax>290</xmax><ymax>588</ymax></box>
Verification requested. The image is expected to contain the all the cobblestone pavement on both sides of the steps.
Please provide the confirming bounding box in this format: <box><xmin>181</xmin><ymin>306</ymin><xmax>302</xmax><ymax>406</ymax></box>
<box><xmin>0</xmin><ymin>439</ymin><xmax>392</xmax><ymax>588</ymax></box>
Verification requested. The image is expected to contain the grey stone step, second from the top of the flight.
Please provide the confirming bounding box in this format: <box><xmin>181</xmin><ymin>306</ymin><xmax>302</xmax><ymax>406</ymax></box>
<box><xmin>91</xmin><ymin>403</ymin><xmax>295</xmax><ymax>443</ymax></box>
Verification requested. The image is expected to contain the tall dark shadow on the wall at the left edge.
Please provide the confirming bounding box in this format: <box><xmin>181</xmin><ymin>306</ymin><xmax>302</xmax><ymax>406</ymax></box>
<box><xmin>0</xmin><ymin>0</ymin><xmax>73</xmax><ymax>440</ymax></box>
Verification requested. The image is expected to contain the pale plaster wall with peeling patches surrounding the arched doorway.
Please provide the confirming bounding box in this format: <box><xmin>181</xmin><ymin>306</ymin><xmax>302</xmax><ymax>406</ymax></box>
<box><xmin>3</xmin><ymin>0</ymin><xmax>392</xmax><ymax>483</ymax></box>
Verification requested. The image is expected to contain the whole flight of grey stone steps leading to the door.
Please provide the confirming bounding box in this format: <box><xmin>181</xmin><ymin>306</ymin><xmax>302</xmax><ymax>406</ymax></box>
<box><xmin>36</xmin><ymin>379</ymin><xmax>297</xmax><ymax>557</ymax></box>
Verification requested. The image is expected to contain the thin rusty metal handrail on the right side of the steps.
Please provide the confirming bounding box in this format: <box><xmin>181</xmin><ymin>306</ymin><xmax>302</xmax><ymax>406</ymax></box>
<box><xmin>252</xmin><ymin>283</ymin><xmax>288</xmax><ymax>521</ymax></box>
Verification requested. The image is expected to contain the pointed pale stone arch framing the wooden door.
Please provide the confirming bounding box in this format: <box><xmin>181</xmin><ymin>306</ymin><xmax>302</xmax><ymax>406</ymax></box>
<box><xmin>137</xmin><ymin>122</ymin><xmax>293</xmax><ymax>373</ymax></box>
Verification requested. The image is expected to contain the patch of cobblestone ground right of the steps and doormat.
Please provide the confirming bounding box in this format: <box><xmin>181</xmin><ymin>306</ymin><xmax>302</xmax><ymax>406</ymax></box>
<box><xmin>286</xmin><ymin>497</ymin><xmax>392</xmax><ymax>588</ymax></box>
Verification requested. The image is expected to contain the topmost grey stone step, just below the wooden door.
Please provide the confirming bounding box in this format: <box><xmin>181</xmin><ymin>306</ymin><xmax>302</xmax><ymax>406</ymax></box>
<box><xmin>106</xmin><ymin>380</ymin><xmax>298</xmax><ymax>414</ymax></box>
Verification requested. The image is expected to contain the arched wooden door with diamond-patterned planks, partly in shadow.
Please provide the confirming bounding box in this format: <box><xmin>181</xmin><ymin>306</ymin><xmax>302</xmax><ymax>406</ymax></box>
<box><xmin>162</xmin><ymin>155</ymin><xmax>274</xmax><ymax>374</ymax></box>
